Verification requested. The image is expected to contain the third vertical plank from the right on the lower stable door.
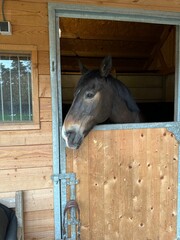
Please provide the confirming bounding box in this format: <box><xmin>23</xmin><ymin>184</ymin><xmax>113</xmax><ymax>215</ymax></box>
<box><xmin>133</xmin><ymin>129</ymin><xmax>148</xmax><ymax>240</ymax></box>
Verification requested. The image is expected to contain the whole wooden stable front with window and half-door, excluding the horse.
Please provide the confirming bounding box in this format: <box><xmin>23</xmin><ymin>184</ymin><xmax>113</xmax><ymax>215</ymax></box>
<box><xmin>0</xmin><ymin>0</ymin><xmax>180</xmax><ymax>240</ymax></box>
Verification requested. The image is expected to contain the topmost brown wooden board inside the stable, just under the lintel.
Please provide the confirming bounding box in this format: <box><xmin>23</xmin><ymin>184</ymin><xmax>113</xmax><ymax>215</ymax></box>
<box><xmin>60</xmin><ymin>18</ymin><xmax>164</xmax><ymax>42</ymax></box>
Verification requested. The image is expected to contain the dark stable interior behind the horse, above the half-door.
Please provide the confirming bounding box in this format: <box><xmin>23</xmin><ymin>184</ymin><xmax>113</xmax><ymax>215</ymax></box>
<box><xmin>60</xmin><ymin>18</ymin><xmax>176</xmax><ymax>122</ymax></box>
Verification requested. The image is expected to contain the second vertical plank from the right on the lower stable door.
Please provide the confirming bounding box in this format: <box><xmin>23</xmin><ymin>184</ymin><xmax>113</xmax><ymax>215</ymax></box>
<box><xmin>146</xmin><ymin>129</ymin><xmax>161</xmax><ymax>239</ymax></box>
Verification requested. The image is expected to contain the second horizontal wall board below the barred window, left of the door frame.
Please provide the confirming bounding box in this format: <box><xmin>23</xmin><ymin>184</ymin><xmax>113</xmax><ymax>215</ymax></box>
<box><xmin>0</xmin><ymin>144</ymin><xmax>52</xmax><ymax>170</ymax></box>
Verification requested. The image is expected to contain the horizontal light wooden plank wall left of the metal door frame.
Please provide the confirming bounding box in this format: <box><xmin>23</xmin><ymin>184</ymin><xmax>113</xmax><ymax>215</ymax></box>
<box><xmin>0</xmin><ymin>1</ymin><xmax>54</xmax><ymax>240</ymax></box>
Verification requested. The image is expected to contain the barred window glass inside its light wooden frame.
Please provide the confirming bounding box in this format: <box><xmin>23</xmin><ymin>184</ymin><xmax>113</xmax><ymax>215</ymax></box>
<box><xmin>0</xmin><ymin>54</ymin><xmax>33</xmax><ymax>122</ymax></box>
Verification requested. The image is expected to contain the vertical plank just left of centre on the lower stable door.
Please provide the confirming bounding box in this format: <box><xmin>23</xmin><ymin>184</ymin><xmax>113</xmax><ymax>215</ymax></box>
<box><xmin>103</xmin><ymin>131</ymin><xmax>121</xmax><ymax>240</ymax></box>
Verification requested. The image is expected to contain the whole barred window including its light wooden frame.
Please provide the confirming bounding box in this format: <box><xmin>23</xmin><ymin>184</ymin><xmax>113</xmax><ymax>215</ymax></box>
<box><xmin>0</xmin><ymin>45</ymin><xmax>39</xmax><ymax>130</ymax></box>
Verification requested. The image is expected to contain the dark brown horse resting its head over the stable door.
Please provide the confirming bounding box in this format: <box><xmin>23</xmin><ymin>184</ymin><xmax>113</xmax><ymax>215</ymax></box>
<box><xmin>62</xmin><ymin>56</ymin><xmax>141</xmax><ymax>149</ymax></box>
